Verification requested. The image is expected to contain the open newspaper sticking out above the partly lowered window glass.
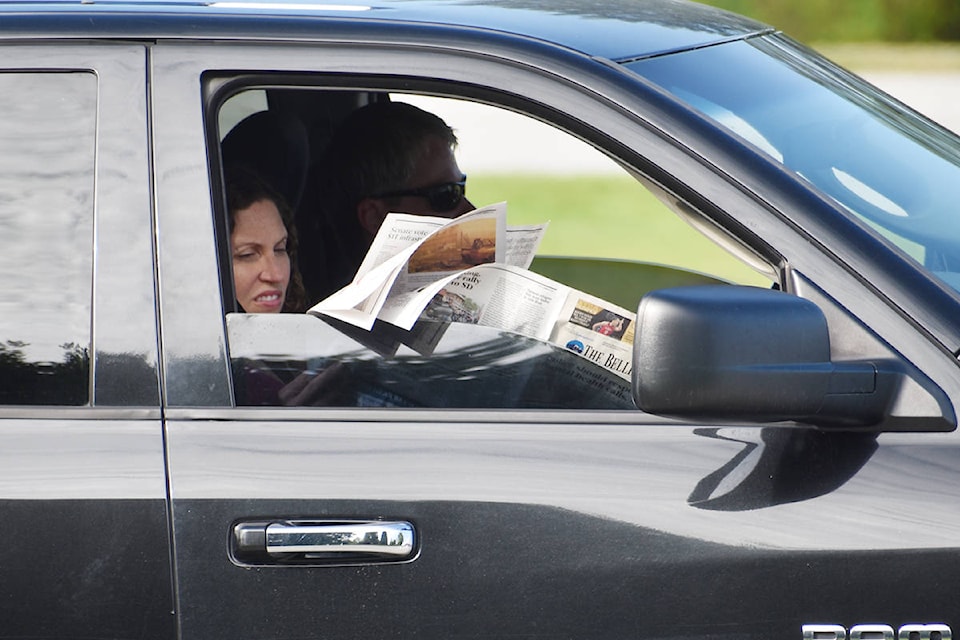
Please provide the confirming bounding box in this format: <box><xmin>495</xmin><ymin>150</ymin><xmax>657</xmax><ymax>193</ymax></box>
<box><xmin>308</xmin><ymin>203</ymin><xmax>636</xmax><ymax>380</ymax></box>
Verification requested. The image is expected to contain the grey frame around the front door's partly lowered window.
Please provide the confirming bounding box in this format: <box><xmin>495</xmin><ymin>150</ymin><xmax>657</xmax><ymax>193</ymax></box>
<box><xmin>155</xmin><ymin>36</ymin><xmax>960</xmax><ymax>420</ymax></box>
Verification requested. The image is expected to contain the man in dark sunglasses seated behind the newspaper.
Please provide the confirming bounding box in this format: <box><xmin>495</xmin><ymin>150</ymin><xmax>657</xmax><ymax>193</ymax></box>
<box><xmin>304</xmin><ymin>102</ymin><xmax>474</xmax><ymax>297</ymax></box>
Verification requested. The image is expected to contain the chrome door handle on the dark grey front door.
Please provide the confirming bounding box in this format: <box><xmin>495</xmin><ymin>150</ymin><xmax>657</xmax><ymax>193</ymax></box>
<box><xmin>232</xmin><ymin>520</ymin><xmax>417</xmax><ymax>564</ymax></box>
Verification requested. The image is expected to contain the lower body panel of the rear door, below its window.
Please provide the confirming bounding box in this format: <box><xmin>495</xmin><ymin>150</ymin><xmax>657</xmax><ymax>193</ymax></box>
<box><xmin>0</xmin><ymin>420</ymin><xmax>174</xmax><ymax>639</ymax></box>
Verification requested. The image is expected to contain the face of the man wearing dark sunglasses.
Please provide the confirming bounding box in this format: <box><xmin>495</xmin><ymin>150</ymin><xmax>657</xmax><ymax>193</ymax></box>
<box><xmin>358</xmin><ymin>137</ymin><xmax>475</xmax><ymax>238</ymax></box>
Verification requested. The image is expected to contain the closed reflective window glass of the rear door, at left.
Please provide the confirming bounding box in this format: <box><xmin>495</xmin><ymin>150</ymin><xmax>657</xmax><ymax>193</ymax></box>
<box><xmin>0</xmin><ymin>73</ymin><xmax>97</xmax><ymax>405</ymax></box>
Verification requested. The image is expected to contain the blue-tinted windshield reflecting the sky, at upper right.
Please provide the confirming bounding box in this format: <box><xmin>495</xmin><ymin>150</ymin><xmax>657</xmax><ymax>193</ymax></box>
<box><xmin>628</xmin><ymin>37</ymin><xmax>960</xmax><ymax>290</ymax></box>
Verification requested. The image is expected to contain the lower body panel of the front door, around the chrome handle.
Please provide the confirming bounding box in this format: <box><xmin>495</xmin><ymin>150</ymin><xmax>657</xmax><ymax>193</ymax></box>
<box><xmin>169</xmin><ymin>416</ymin><xmax>960</xmax><ymax>639</ymax></box>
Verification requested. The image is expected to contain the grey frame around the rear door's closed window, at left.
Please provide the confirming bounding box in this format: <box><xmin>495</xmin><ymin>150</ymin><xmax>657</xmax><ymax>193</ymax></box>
<box><xmin>0</xmin><ymin>42</ymin><xmax>160</xmax><ymax>416</ymax></box>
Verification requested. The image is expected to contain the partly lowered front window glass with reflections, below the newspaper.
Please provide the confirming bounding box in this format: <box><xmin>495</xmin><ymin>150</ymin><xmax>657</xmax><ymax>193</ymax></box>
<box><xmin>221</xmin><ymin>313</ymin><xmax>636</xmax><ymax>411</ymax></box>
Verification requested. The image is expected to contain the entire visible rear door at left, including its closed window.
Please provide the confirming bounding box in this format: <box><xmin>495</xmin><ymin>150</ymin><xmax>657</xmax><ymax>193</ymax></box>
<box><xmin>0</xmin><ymin>42</ymin><xmax>175</xmax><ymax>640</ymax></box>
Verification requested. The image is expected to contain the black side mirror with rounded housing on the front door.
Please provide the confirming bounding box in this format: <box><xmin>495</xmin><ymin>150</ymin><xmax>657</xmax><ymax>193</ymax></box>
<box><xmin>633</xmin><ymin>285</ymin><xmax>900</xmax><ymax>427</ymax></box>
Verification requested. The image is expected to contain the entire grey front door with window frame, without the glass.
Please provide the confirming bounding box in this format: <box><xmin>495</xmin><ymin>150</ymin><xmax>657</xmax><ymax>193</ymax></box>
<box><xmin>153</xmin><ymin>44</ymin><xmax>960</xmax><ymax>640</ymax></box>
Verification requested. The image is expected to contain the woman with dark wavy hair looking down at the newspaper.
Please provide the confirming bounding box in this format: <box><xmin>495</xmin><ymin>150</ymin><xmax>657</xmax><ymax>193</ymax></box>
<box><xmin>226</xmin><ymin>169</ymin><xmax>306</xmax><ymax>313</ymax></box>
